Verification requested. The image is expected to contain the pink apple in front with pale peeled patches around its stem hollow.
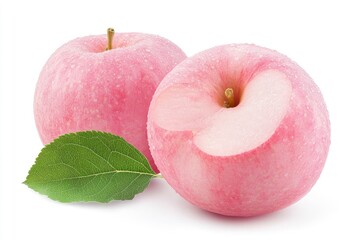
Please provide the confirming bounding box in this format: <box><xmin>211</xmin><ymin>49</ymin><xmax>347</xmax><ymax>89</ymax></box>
<box><xmin>148</xmin><ymin>44</ymin><xmax>330</xmax><ymax>216</ymax></box>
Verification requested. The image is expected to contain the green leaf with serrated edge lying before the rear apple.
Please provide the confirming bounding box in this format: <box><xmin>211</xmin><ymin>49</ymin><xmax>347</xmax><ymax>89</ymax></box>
<box><xmin>24</xmin><ymin>131</ymin><xmax>158</xmax><ymax>202</ymax></box>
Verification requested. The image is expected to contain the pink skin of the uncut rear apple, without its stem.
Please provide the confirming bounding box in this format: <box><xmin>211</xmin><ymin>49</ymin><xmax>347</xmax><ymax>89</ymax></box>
<box><xmin>34</xmin><ymin>33</ymin><xmax>186</xmax><ymax>171</ymax></box>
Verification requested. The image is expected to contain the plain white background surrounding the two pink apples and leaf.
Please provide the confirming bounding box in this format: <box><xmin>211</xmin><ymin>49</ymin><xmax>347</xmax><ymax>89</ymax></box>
<box><xmin>0</xmin><ymin>0</ymin><xmax>360</xmax><ymax>240</ymax></box>
